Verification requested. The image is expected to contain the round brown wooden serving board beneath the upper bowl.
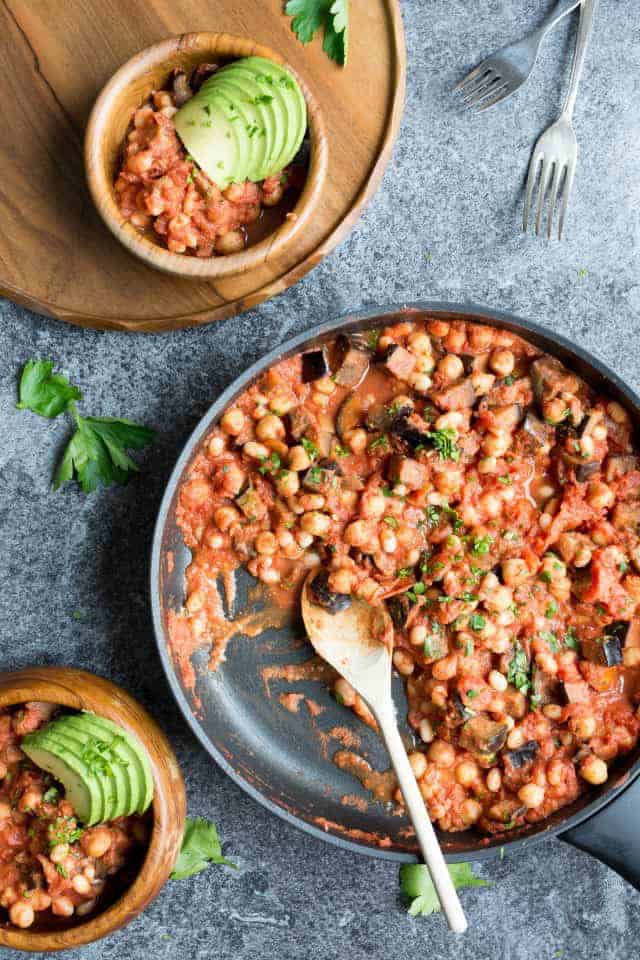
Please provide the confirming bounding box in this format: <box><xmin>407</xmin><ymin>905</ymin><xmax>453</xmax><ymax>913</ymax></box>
<box><xmin>0</xmin><ymin>0</ymin><xmax>405</xmax><ymax>332</ymax></box>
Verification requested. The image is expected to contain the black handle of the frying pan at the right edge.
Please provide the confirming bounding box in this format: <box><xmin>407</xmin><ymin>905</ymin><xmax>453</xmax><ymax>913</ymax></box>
<box><xmin>558</xmin><ymin>777</ymin><xmax>640</xmax><ymax>890</ymax></box>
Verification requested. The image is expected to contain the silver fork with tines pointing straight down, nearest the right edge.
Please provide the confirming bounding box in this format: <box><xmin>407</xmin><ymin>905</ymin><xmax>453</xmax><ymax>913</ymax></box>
<box><xmin>523</xmin><ymin>0</ymin><xmax>598</xmax><ymax>240</ymax></box>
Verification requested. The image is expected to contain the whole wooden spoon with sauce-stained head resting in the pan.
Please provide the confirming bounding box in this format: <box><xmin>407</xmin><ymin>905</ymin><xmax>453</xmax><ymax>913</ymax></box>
<box><xmin>302</xmin><ymin>571</ymin><xmax>467</xmax><ymax>933</ymax></box>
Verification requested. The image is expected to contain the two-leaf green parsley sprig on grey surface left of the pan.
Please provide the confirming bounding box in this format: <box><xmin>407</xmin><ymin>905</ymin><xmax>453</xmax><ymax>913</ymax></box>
<box><xmin>17</xmin><ymin>360</ymin><xmax>155</xmax><ymax>493</ymax></box>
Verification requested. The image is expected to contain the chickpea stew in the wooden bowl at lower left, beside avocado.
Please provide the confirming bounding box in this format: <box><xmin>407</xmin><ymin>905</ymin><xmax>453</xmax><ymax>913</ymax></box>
<box><xmin>0</xmin><ymin>701</ymin><xmax>148</xmax><ymax>929</ymax></box>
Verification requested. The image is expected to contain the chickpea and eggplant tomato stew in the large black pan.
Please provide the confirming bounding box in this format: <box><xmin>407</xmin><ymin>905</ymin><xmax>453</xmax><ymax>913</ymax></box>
<box><xmin>171</xmin><ymin>313</ymin><xmax>640</xmax><ymax>834</ymax></box>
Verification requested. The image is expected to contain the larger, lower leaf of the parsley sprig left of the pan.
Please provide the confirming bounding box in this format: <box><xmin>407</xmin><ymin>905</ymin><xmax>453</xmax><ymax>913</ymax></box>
<box><xmin>53</xmin><ymin>410</ymin><xmax>155</xmax><ymax>493</ymax></box>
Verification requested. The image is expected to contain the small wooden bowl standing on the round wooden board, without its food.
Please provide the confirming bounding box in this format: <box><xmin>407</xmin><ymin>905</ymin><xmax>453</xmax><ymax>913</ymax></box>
<box><xmin>85</xmin><ymin>32</ymin><xmax>328</xmax><ymax>280</ymax></box>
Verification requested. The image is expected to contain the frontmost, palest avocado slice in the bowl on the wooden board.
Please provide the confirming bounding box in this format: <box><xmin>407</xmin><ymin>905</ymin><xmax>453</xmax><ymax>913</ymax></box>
<box><xmin>173</xmin><ymin>95</ymin><xmax>242</xmax><ymax>190</ymax></box>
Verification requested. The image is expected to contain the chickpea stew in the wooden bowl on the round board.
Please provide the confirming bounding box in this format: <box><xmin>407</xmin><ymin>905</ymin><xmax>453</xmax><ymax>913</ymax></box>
<box><xmin>115</xmin><ymin>58</ymin><xmax>308</xmax><ymax>257</ymax></box>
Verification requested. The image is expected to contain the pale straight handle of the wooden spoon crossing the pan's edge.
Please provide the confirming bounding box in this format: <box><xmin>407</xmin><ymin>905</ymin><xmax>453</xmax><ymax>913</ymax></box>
<box><xmin>376</xmin><ymin>706</ymin><xmax>467</xmax><ymax>933</ymax></box>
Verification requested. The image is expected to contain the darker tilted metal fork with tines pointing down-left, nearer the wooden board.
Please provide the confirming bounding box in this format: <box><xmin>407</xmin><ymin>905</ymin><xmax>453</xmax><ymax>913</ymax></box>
<box><xmin>454</xmin><ymin>0</ymin><xmax>581</xmax><ymax>110</ymax></box>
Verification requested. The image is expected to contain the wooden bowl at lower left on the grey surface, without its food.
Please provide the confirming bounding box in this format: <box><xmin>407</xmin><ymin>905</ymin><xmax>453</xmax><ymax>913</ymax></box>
<box><xmin>0</xmin><ymin>667</ymin><xmax>187</xmax><ymax>953</ymax></box>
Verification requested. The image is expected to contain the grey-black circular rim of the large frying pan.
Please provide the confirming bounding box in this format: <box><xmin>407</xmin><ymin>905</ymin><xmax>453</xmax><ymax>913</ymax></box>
<box><xmin>149</xmin><ymin>300</ymin><xmax>640</xmax><ymax>863</ymax></box>
